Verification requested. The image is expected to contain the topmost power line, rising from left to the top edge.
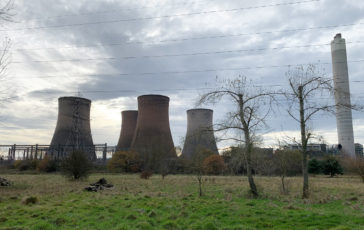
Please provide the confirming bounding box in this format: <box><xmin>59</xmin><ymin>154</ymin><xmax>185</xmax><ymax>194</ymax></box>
<box><xmin>0</xmin><ymin>0</ymin><xmax>321</xmax><ymax>32</ymax></box>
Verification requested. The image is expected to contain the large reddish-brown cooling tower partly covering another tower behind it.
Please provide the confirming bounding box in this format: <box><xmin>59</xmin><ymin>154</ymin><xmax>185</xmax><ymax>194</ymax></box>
<box><xmin>131</xmin><ymin>95</ymin><xmax>176</xmax><ymax>168</ymax></box>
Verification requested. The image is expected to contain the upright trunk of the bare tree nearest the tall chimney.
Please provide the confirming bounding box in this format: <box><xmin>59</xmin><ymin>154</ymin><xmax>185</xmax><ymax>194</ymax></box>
<box><xmin>298</xmin><ymin>86</ymin><xmax>309</xmax><ymax>199</ymax></box>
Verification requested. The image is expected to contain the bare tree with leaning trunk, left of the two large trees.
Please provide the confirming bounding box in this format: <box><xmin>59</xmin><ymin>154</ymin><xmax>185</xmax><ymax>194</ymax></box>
<box><xmin>198</xmin><ymin>76</ymin><xmax>274</xmax><ymax>197</ymax></box>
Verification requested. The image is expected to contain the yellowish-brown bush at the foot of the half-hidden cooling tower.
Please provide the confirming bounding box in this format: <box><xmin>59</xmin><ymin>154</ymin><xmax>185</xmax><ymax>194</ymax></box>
<box><xmin>107</xmin><ymin>151</ymin><xmax>141</xmax><ymax>173</ymax></box>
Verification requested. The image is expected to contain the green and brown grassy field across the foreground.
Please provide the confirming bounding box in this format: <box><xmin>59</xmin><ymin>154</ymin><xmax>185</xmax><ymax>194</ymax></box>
<box><xmin>0</xmin><ymin>174</ymin><xmax>364</xmax><ymax>230</ymax></box>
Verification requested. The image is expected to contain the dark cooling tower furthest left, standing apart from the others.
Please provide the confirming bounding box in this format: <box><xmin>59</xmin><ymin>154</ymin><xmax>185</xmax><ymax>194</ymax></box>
<box><xmin>50</xmin><ymin>97</ymin><xmax>96</xmax><ymax>160</ymax></box>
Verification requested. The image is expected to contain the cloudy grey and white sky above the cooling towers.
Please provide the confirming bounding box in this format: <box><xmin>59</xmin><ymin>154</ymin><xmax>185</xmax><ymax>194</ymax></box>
<box><xmin>0</xmin><ymin>0</ymin><xmax>364</xmax><ymax>149</ymax></box>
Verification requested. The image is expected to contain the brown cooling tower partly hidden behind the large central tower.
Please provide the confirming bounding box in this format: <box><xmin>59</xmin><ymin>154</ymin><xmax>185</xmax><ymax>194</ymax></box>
<box><xmin>116</xmin><ymin>110</ymin><xmax>138</xmax><ymax>151</ymax></box>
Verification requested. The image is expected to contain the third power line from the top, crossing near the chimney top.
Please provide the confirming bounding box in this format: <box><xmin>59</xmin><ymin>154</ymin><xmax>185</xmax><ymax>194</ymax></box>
<box><xmin>11</xmin><ymin>41</ymin><xmax>364</xmax><ymax>64</ymax></box>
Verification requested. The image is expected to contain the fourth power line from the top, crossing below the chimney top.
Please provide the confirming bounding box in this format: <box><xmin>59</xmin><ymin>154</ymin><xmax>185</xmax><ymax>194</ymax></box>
<box><xmin>15</xmin><ymin>59</ymin><xmax>364</xmax><ymax>79</ymax></box>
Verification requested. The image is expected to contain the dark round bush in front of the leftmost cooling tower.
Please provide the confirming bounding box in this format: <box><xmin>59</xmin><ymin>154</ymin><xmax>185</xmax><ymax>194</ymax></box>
<box><xmin>61</xmin><ymin>150</ymin><xmax>92</xmax><ymax>180</ymax></box>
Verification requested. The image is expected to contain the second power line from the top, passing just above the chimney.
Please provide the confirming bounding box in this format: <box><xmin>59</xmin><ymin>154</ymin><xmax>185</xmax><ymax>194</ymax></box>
<box><xmin>7</xmin><ymin>23</ymin><xmax>364</xmax><ymax>51</ymax></box>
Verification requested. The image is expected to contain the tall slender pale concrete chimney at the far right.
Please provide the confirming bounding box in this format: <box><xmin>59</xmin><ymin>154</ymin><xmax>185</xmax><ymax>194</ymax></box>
<box><xmin>331</xmin><ymin>34</ymin><xmax>355</xmax><ymax>156</ymax></box>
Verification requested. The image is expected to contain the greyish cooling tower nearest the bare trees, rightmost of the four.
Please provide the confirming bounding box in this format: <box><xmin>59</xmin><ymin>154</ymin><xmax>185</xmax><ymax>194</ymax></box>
<box><xmin>182</xmin><ymin>109</ymin><xmax>218</xmax><ymax>158</ymax></box>
